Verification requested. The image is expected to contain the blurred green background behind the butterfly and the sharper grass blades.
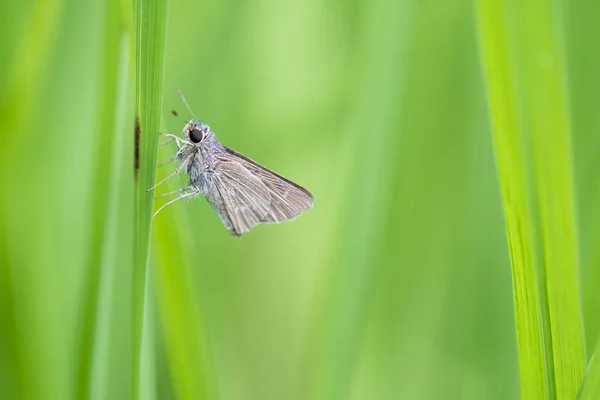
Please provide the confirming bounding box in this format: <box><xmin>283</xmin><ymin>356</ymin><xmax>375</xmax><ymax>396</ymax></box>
<box><xmin>0</xmin><ymin>0</ymin><xmax>600</xmax><ymax>400</ymax></box>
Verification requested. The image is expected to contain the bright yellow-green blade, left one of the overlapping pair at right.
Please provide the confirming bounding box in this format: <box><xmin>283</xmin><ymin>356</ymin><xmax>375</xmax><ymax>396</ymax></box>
<box><xmin>477</xmin><ymin>0</ymin><xmax>548</xmax><ymax>398</ymax></box>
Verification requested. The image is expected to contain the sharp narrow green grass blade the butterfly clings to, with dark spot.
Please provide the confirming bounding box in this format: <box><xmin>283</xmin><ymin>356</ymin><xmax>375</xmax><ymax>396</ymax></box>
<box><xmin>132</xmin><ymin>0</ymin><xmax>167</xmax><ymax>399</ymax></box>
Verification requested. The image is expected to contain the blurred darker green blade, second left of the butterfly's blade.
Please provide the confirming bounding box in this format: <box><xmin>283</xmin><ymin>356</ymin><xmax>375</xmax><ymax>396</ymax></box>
<box><xmin>76</xmin><ymin>0</ymin><xmax>132</xmax><ymax>398</ymax></box>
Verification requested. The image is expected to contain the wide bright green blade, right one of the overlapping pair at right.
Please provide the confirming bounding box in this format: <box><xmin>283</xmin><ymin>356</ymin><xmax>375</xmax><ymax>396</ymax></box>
<box><xmin>520</xmin><ymin>1</ymin><xmax>585</xmax><ymax>399</ymax></box>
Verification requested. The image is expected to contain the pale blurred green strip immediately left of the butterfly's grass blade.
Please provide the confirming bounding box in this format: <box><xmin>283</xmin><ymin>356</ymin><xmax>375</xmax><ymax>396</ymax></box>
<box><xmin>88</xmin><ymin>35</ymin><xmax>134</xmax><ymax>400</ymax></box>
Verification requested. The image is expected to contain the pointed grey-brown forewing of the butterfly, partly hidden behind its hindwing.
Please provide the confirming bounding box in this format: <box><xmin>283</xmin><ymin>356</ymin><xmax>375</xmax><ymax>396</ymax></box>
<box><xmin>217</xmin><ymin>147</ymin><xmax>313</xmax><ymax>223</ymax></box>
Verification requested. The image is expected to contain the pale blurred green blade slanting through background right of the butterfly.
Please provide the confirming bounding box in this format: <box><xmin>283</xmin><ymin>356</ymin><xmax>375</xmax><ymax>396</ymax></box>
<box><xmin>304</xmin><ymin>1</ymin><xmax>412</xmax><ymax>399</ymax></box>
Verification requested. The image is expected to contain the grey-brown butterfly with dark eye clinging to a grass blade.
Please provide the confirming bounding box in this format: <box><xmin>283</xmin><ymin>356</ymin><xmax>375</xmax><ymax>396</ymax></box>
<box><xmin>148</xmin><ymin>92</ymin><xmax>313</xmax><ymax>237</ymax></box>
